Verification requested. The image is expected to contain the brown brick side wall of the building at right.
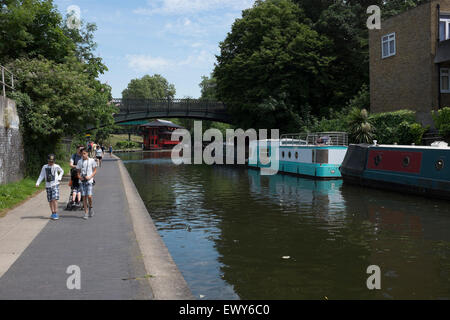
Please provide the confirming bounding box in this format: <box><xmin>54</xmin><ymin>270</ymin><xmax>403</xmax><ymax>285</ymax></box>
<box><xmin>369</xmin><ymin>1</ymin><xmax>434</xmax><ymax>113</ymax></box>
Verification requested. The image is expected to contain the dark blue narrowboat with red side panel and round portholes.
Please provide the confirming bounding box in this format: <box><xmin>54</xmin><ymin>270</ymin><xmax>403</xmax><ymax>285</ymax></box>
<box><xmin>340</xmin><ymin>141</ymin><xmax>450</xmax><ymax>199</ymax></box>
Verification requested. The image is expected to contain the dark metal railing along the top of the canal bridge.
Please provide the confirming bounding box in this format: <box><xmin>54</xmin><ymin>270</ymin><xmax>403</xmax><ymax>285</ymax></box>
<box><xmin>112</xmin><ymin>99</ymin><xmax>226</xmax><ymax>115</ymax></box>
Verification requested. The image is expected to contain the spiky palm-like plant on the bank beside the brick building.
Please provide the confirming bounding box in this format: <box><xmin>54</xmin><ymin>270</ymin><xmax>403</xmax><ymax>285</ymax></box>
<box><xmin>348</xmin><ymin>108</ymin><xmax>375</xmax><ymax>143</ymax></box>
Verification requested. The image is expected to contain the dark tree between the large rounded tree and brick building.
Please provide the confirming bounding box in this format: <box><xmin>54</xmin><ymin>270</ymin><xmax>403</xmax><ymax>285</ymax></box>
<box><xmin>292</xmin><ymin>0</ymin><xmax>428</xmax><ymax>115</ymax></box>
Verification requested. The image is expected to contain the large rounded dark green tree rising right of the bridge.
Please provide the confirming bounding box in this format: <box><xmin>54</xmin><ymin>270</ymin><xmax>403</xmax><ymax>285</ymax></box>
<box><xmin>214</xmin><ymin>0</ymin><xmax>333</xmax><ymax>131</ymax></box>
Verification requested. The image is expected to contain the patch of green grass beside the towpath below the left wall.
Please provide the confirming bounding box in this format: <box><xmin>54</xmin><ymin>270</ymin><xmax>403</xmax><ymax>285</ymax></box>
<box><xmin>0</xmin><ymin>178</ymin><xmax>45</xmax><ymax>218</ymax></box>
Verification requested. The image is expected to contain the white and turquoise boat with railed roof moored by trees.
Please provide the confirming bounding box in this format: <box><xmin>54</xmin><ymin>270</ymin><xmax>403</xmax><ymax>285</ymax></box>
<box><xmin>248</xmin><ymin>132</ymin><xmax>348</xmax><ymax>179</ymax></box>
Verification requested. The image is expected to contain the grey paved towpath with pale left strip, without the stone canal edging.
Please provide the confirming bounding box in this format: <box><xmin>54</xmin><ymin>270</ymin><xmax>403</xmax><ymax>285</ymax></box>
<box><xmin>0</xmin><ymin>158</ymin><xmax>153</xmax><ymax>300</ymax></box>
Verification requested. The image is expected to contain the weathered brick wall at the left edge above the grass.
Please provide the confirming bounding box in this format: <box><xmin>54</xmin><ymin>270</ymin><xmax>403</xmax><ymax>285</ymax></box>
<box><xmin>0</xmin><ymin>97</ymin><xmax>25</xmax><ymax>184</ymax></box>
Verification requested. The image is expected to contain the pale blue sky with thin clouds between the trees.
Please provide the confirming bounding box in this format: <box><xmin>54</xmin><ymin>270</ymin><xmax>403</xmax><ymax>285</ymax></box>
<box><xmin>54</xmin><ymin>0</ymin><xmax>254</xmax><ymax>98</ymax></box>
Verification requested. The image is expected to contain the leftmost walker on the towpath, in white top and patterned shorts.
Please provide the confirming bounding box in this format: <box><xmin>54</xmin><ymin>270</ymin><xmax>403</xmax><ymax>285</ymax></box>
<box><xmin>36</xmin><ymin>154</ymin><xmax>64</xmax><ymax>220</ymax></box>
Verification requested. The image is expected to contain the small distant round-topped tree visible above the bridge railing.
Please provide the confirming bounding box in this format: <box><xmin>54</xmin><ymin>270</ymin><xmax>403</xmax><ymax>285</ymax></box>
<box><xmin>122</xmin><ymin>74</ymin><xmax>176</xmax><ymax>99</ymax></box>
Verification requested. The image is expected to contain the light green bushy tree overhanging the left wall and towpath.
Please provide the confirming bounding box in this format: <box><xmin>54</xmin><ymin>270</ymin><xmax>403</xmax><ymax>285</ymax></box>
<box><xmin>8</xmin><ymin>58</ymin><xmax>116</xmax><ymax>174</ymax></box>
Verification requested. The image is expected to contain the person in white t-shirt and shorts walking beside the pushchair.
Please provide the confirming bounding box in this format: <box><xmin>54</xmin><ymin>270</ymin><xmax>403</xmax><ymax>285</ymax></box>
<box><xmin>77</xmin><ymin>149</ymin><xmax>97</xmax><ymax>219</ymax></box>
